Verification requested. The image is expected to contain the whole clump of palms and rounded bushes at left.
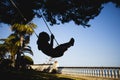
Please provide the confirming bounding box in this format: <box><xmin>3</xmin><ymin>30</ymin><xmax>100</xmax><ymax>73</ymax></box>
<box><xmin>0</xmin><ymin>23</ymin><xmax>37</xmax><ymax>69</ymax></box>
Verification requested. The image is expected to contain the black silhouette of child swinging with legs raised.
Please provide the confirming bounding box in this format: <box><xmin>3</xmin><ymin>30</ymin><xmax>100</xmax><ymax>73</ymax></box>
<box><xmin>37</xmin><ymin>32</ymin><xmax>74</xmax><ymax>58</ymax></box>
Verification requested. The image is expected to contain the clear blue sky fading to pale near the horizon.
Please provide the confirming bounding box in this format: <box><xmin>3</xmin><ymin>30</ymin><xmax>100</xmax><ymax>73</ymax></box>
<box><xmin>0</xmin><ymin>3</ymin><xmax>120</xmax><ymax>67</ymax></box>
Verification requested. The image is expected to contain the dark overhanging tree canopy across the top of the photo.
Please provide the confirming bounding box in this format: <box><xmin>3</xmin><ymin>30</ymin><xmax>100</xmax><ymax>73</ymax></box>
<box><xmin>0</xmin><ymin>0</ymin><xmax>120</xmax><ymax>26</ymax></box>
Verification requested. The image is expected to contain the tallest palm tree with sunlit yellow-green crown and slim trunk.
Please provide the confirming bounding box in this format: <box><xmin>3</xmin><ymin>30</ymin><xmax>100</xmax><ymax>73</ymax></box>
<box><xmin>11</xmin><ymin>23</ymin><xmax>36</xmax><ymax>67</ymax></box>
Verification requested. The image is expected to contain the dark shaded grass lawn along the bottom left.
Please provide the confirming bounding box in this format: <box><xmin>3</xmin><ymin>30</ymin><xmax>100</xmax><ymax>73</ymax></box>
<box><xmin>0</xmin><ymin>70</ymin><xmax>79</xmax><ymax>80</ymax></box>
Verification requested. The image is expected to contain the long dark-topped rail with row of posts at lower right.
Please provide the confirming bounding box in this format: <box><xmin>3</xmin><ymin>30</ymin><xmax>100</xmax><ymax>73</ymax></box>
<box><xmin>58</xmin><ymin>67</ymin><xmax>120</xmax><ymax>79</ymax></box>
